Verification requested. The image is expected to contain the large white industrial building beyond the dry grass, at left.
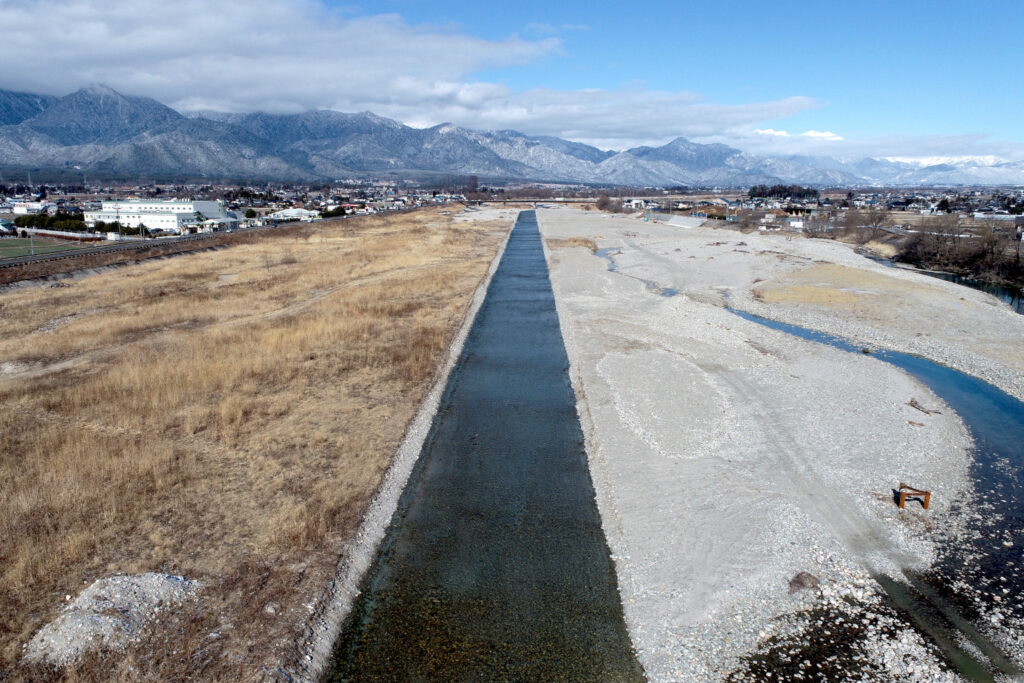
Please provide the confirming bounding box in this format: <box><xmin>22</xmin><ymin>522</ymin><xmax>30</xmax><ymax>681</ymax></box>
<box><xmin>83</xmin><ymin>200</ymin><xmax>237</xmax><ymax>232</ymax></box>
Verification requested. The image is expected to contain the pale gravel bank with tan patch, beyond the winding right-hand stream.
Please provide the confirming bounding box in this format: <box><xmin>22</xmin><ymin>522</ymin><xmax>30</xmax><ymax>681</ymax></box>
<box><xmin>600</xmin><ymin>218</ymin><xmax>1024</xmax><ymax>399</ymax></box>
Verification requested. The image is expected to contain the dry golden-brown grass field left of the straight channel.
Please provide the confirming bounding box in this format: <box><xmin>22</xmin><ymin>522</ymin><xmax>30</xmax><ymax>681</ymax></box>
<box><xmin>0</xmin><ymin>210</ymin><xmax>510</xmax><ymax>680</ymax></box>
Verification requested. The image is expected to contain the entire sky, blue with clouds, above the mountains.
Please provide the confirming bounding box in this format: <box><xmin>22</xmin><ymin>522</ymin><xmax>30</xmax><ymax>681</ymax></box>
<box><xmin>0</xmin><ymin>0</ymin><xmax>1024</xmax><ymax>159</ymax></box>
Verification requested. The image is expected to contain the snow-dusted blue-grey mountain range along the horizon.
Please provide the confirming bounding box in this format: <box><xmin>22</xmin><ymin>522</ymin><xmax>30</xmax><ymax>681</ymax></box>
<box><xmin>0</xmin><ymin>85</ymin><xmax>1024</xmax><ymax>187</ymax></box>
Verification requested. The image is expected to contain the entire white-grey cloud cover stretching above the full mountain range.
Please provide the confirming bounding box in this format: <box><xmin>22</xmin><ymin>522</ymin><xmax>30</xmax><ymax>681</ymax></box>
<box><xmin>0</xmin><ymin>0</ymin><xmax>1024</xmax><ymax>158</ymax></box>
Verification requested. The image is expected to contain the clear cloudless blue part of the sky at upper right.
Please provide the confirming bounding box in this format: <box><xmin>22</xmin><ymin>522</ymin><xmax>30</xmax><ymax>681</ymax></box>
<box><xmin>348</xmin><ymin>0</ymin><xmax>1024</xmax><ymax>148</ymax></box>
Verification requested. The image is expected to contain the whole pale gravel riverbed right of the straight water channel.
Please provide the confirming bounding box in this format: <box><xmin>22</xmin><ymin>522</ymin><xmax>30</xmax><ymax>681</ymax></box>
<box><xmin>539</xmin><ymin>209</ymin><xmax>1024</xmax><ymax>681</ymax></box>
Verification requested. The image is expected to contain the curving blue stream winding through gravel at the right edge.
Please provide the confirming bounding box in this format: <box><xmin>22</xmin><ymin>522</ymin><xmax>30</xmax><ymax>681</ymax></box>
<box><xmin>731</xmin><ymin>309</ymin><xmax>1024</xmax><ymax>681</ymax></box>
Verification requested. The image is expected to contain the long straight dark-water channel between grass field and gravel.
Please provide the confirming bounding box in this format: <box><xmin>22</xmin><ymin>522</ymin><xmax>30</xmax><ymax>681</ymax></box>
<box><xmin>330</xmin><ymin>211</ymin><xmax>643</xmax><ymax>681</ymax></box>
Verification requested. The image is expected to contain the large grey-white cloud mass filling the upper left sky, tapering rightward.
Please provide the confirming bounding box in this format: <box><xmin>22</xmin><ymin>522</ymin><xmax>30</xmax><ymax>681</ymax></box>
<box><xmin>0</xmin><ymin>0</ymin><xmax>560</xmax><ymax>112</ymax></box>
